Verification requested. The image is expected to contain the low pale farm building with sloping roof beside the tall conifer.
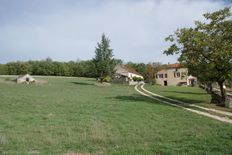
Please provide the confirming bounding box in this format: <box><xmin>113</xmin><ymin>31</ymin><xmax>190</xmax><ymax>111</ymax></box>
<box><xmin>113</xmin><ymin>64</ymin><xmax>144</xmax><ymax>85</ymax></box>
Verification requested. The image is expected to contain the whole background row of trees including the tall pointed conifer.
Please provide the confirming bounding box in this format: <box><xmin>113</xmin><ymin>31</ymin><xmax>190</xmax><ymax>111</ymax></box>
<box><xmin>0</xmin><ymin>33</ymin><xmax>162</xmax><ymax>83</ymax></box>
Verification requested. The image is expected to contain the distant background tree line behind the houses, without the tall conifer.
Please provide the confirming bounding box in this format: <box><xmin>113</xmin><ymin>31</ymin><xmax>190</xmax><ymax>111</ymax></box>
<box><xmin>0</xmin><ymin>58</ymin><xmax>162</xmax><ymax>83</ymax></box>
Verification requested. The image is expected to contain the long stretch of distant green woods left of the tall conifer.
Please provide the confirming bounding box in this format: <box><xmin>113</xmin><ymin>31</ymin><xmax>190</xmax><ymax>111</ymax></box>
<box><xmin>0</xmin><ymin>58</ymin><xmax>96</xmax><ymax>77</ymax></box>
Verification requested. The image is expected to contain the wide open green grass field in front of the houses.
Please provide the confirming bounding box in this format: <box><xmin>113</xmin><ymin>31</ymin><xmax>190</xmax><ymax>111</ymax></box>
<box><xmin>0</xmin><ymin>77</ymin><xmax>232</xmax><ymax>155</ymax></box>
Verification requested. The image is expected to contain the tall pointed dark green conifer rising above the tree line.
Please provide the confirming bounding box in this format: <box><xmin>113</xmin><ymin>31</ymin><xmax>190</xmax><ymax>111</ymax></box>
<box><xmin>93</xmin><ymin>34</ymin><xmax>116</xmax><ymax>82</ymax></box>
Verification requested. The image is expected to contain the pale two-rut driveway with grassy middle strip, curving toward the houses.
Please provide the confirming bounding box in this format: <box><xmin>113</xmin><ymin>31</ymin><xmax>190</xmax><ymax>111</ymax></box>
<box><xmin>135</xmin><ymin>84</ymin><xmax>232</xmax><ymax>124</ymax></box>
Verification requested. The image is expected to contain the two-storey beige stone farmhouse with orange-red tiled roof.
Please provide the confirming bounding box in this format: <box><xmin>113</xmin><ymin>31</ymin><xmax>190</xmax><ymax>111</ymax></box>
<box><xmin>156</xmin><ymin>63</ymin><xmax>197</xmax><ymax>86</ymax></box>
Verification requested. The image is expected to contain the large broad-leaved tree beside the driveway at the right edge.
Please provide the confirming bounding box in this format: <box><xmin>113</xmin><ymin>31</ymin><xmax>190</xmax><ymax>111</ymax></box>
<box><xmin>164</xmin><ymin>8</ymin><xmax>232</xmax><ymax>103</ymax></box>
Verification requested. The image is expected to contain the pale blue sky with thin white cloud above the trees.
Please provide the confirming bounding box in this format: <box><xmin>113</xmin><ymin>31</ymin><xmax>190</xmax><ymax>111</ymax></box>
<box><xmin>0</xmin><ymin>0</ymin><xmax>232</xmax><ymax>64</ymax></box>
